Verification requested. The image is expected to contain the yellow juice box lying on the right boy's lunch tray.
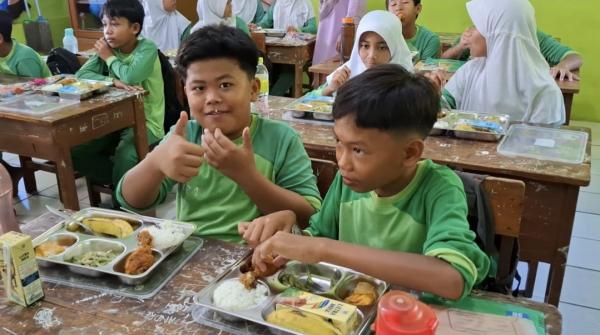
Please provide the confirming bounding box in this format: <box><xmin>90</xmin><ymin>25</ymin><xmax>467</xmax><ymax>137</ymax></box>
<box><xmin>276</xmin><ymin>288</ymin><xmax>358</xmax><ymax>334</ymax></box>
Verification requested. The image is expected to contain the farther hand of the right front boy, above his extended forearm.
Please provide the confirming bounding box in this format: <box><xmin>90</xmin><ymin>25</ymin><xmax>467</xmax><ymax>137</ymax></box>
<box><xmin>238</xmin><ymin>210</ymin><xmax>296</xmax><ymax>248</ymax></box>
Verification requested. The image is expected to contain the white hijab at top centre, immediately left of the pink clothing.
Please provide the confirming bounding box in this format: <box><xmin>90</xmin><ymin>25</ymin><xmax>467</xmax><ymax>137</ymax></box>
<box><xmin>258</xmin><ymin>0</ymin><xmax>317</xmax><ymax>34</ymax></box>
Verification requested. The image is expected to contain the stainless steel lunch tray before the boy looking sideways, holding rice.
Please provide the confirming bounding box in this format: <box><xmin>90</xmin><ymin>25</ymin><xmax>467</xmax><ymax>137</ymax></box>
<box><xmin>192</xmin><ymin>258</ymin><xmax>389</xmax><ymax>335</ymax></box>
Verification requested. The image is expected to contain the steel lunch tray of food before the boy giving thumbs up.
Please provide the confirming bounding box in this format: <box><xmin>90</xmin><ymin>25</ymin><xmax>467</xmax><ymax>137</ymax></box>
<box><xmin>33</xmin><ymin>208</ymin><xmax>195</xmax><ymax>285</ymax></box>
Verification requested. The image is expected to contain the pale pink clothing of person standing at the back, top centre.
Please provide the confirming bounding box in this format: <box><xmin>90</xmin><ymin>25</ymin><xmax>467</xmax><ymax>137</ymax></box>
<box><xmin>313</xmin><ymin>0</ymin><xmax>367</xmax><ymax>64</ymax></box>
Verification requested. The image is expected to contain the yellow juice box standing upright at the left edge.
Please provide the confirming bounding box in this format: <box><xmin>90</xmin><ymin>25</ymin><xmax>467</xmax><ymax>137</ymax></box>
<box><xmin>0</xmin><ymin>232</ymin><xmax>44</xmax><ymax>307</ymax></box>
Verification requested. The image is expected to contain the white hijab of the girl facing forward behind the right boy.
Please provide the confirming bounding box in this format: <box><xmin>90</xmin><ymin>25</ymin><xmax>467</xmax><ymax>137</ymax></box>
<box><xmin>327</xmin><ymin>10</ymin><xmax>413</xmax><ymax>83</ymax></box>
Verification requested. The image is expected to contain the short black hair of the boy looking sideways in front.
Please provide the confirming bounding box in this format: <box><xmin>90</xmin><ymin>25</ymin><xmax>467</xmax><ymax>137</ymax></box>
<box><xmin>333</xmin><ymin>64</ymin><xmax>440</xmax><ymax>138</ymax></box>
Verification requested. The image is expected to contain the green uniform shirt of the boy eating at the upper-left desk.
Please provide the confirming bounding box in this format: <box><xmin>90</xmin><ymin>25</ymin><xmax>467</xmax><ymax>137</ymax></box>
<box><xmin>77</xmin><ymin>38</ymin><xmax>165</xmax><ymax>138</ymax></box>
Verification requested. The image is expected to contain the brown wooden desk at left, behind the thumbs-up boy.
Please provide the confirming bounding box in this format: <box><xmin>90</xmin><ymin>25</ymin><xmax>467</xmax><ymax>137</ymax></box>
<box><xmin>0</xmin><ymin>82</ymin><xmax>148</xmax><ymax>210</ymax></box>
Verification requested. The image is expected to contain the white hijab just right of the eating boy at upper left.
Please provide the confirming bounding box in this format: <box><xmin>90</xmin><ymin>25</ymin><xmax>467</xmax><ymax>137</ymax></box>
<box><xmin>142</xmin><ymin>0</ymin><xmax>190</xmax><ymax>51</ymax></box>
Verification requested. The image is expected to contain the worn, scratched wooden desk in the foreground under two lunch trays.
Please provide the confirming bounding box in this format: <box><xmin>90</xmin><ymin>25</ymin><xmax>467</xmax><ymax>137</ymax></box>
<box><xmin>0</xmin><ymin>213</ymin><xmax>562</xmax><ymax>335</ymax></box>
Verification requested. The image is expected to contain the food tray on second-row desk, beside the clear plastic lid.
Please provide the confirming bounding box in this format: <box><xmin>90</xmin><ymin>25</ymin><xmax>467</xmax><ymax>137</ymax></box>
<box><xmin>431</xmin><ymin>110</ymin><xmax>510</xmax><ymax>142</ymax></box>
